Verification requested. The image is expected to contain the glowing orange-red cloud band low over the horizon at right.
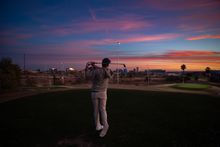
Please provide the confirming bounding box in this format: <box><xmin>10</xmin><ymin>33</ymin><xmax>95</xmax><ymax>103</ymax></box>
<box><xmin>103</xmin><ymin>50</ymin><xmax>220</xmax><ymax>70</ymax></box>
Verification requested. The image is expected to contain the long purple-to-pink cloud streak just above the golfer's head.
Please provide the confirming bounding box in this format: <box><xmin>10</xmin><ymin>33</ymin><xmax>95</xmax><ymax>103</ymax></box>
<box><xmin>7</xmin><ymin>34</ymin><xmax>179</xmax><ymax>61</ymax></box>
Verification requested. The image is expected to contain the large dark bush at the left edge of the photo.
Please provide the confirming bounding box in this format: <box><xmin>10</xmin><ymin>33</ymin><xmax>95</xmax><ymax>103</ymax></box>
<box><xmin>0</xmin><ymin>58</ymin><xmax>21</xmax><ymax>89</ymax></box>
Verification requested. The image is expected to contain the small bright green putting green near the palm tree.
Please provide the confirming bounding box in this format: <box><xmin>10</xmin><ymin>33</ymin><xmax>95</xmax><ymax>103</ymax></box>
<box><xmin>173</xmin><ymin>83</ymin><xmax>210</xmax><ymax>90</ymax></box>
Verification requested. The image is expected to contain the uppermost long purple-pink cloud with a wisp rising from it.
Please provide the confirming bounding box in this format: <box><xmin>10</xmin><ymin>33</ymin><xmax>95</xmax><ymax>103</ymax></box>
<box><xmin>42</xmin><ymin>14</ymin><xmax>152</xmax><ymax>36</ymax></box>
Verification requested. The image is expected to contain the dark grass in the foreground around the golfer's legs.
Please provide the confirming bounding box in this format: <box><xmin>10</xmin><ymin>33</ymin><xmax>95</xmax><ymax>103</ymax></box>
<box><xmin>0</xmin><ymin>90</ymin><xmax>220</xmax><ymax>147</ymax></box>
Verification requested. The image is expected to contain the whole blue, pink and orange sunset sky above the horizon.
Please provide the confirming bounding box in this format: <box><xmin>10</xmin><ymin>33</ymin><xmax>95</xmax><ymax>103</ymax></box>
<box><xmin>0</xmin><ymin>0</ymin><xmax>220</xmax><ymax>71</ymax></box>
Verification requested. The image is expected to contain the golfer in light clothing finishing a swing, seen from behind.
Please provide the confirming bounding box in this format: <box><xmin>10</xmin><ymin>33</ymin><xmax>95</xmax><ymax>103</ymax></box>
<box><xmin>85</xmin><ymin>58</ymin><xmax>113</xmax><ymax>137</ymax></box>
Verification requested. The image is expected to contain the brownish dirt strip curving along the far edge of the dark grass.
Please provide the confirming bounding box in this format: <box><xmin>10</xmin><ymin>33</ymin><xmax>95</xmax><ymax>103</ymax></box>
<box><xmin>0</xmin><ymin>84</ymin><xmax>220</xmax><ymax>103</ymax></box>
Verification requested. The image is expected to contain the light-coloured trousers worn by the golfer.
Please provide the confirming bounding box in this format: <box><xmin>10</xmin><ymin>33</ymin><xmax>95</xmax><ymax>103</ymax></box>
<box><xmin>92</xmin><ymin>91</ymin><xmax>108</xmax><ymax>128</ymax></box>
